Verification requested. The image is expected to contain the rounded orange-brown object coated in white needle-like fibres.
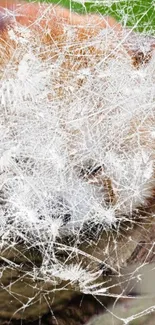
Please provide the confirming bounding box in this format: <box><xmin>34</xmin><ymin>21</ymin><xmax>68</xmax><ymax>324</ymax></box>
<box><xmin>0</xmin><ymin>1</ymin><xmax>155</xmax><ymax>231</ymax></box>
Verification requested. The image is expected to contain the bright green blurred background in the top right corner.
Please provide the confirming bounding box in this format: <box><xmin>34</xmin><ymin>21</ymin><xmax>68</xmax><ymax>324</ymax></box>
<box><xmin>29</xmin><ymin>0</ymin><xmax>155</xmax><ymax>34</ymax></box>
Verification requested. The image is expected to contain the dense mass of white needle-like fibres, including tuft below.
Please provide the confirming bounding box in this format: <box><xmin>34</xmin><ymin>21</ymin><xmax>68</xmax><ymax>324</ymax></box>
<box><xmin>0</xmin><ymin>2</ymin><xmax>155</xmax><ymax>316</ymax></box>
